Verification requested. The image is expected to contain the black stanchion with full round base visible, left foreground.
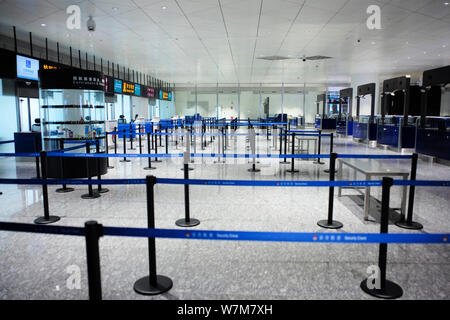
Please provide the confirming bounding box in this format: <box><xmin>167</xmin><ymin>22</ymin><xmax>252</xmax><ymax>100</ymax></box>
<box><xmin>134</xmin><ymin>176</ymin><xmax>173</xmax><ymax>295</ymax></box>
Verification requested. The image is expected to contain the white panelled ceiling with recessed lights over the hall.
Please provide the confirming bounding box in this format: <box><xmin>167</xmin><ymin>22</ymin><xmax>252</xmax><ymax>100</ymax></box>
<box><xmin>0</xmin><ymin>0</ymin><xmax>450</xmax><ymax>84</ymax></box>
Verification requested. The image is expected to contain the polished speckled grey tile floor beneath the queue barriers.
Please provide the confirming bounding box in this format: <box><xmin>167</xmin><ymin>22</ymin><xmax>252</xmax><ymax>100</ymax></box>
<box><xmin>0</xmin><ymin>129</ymin><xmax>450</xmax><ymax>299</ymax></box>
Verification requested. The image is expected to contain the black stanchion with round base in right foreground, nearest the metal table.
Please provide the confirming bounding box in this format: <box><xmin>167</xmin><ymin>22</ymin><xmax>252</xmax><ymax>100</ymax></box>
<box><xmin>360</xmin><ymin>177</ymin><xmax>403</xmax><ymax>299</ymax></box>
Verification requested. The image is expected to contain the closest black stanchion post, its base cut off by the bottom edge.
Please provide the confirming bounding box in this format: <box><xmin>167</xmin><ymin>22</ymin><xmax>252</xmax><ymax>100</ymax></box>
<box><xmin>84</xmin><ymin>221</ymin><xmax>103</xmax><ymax>301</ymax></box>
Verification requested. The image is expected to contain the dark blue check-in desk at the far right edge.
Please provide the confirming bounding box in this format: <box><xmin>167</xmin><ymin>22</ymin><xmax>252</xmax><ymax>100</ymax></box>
<box><xmin>416</xmin><ymin>117</ymin><xmax>450</xmax><ymax>160</ymax></box>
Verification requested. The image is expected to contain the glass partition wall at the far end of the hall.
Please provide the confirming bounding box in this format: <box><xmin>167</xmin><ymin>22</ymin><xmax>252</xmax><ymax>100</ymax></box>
<box><xmin>173</xmin><ymin>83</ymin><xmax>326</xmax><ymax>125</ymax></box>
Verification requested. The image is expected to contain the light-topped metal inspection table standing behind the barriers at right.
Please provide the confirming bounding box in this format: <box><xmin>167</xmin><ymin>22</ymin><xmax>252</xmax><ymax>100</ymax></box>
<box><xmin>337</xmin><ymin>159</ymin><xmax>409</xmax><ymax>220</ymax></box>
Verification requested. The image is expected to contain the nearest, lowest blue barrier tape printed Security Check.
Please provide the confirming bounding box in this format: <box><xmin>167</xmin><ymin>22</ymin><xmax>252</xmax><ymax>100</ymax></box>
<box><xmin>0</xmin><ymin>222</ymin><xmax>450</xmax><ymax>244</ymax></box>
